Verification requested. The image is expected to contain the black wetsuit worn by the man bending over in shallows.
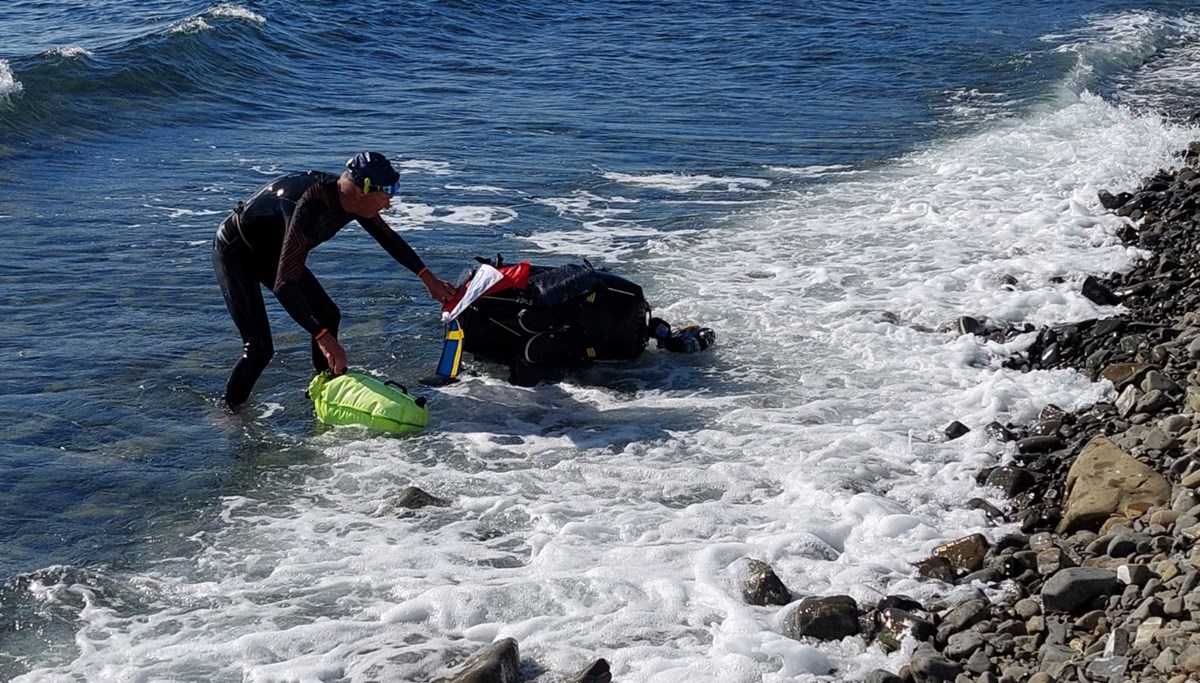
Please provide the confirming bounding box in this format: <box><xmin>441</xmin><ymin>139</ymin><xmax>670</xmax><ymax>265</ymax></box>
<box><xmin>212</xmin><ymin>170</ymin><xmax>425</xmax><ymax>406</ymax></box>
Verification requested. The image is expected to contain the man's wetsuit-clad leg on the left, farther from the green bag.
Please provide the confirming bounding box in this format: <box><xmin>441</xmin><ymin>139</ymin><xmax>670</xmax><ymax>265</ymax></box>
<box><xmin>212</xmin><ymin>241</ymin><xmax>275</xmax><ymax>407</ymax></box>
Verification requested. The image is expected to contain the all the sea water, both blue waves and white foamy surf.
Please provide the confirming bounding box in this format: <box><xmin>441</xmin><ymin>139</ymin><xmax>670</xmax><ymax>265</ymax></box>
<box><xmin>0</xmin><ymin>0</ymin><xmax>1200</xmax><ymax>683</ymax></box>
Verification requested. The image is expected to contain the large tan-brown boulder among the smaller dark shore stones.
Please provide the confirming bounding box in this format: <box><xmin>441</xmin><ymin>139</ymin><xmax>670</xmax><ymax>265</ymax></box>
<box><xmin>1058</xmin><ymin>436</ymin><xmax>1171</xmax><ymax>534</ymax></box>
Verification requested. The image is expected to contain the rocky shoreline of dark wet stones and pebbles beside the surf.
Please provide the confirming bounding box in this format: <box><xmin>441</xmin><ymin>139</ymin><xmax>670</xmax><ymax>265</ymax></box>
<box><xmin>424</xmin><ymin>142</ymin><xmax>1200</xmax><ymax>683</ymax></box>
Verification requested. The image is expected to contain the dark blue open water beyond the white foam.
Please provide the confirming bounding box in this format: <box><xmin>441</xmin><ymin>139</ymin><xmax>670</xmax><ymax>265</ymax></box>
<box><xmin>0</xmin><ymin>0</ymin><xmax>1198</xmax><ymax>673</ymax></box>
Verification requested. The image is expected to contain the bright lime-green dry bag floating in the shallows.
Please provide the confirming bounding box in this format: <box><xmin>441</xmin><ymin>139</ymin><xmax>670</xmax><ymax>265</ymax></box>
<box><xmin>308</xmin><ymin>371</ymin><xmax>430</xmax><ymax>435</ymax></box>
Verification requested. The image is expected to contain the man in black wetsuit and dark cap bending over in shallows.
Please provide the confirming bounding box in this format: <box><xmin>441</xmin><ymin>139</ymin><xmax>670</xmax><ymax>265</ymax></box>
<box><xmin>212</xmin><ymin>151</ymin><xmax>455</xmax><ymax>407</ymax></box>
